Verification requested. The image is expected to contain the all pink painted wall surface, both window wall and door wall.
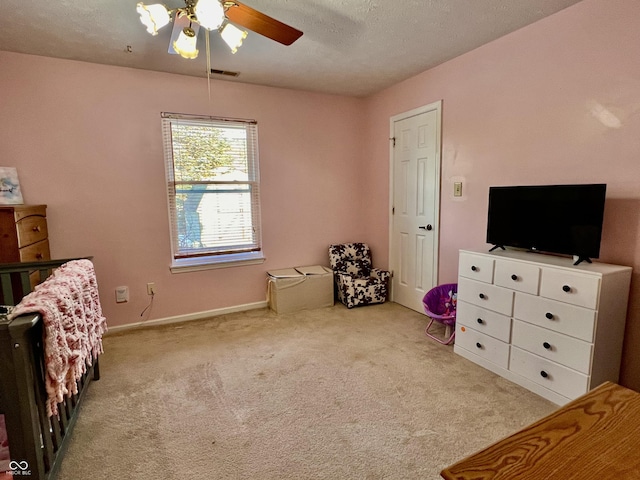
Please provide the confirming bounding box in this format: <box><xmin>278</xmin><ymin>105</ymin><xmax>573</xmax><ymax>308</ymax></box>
<box><xmin>0</xmin><ymin>0</ymin><xmax>640</xmax><ymax>390</ymax></box>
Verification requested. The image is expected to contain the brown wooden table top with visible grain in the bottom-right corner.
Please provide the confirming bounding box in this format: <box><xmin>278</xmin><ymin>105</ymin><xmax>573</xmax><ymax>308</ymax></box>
<box><xmin>440</xmin><ymin>382</ymin><xmax>640</xmax><ymax>480</ymax></box>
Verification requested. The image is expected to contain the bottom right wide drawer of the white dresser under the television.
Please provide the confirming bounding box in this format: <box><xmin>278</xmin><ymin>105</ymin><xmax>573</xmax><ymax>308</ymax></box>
<box><xmin>510</xmin><ymin>346</ymin><xmax>589</xmax><ymax>399</ymax></box>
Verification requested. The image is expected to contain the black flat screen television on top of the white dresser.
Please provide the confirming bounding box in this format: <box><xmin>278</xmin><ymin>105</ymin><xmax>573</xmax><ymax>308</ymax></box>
<box><xmin>487</xmin><ymin>184</ymin><xmax>607</xmax><ymax>264</ymax></box>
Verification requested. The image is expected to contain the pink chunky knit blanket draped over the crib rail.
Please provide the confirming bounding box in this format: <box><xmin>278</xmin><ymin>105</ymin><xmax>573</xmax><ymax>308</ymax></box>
<box><xmin>11</xmin><ymin>260</ymin><xmax>107</xmax><ymax>415</ymax></box>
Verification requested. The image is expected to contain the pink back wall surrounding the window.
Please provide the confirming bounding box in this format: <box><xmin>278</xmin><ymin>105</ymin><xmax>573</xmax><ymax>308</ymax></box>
<box><xmin>0</xmin><ymin>52</ymin><xmax>366</xmax><ymax>326</ymax></box>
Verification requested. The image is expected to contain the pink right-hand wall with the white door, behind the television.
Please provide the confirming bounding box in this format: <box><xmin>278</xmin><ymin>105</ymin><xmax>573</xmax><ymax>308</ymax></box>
<box><xmin>367</xmin><ymin>0</ymin><xmax>640</xmax><ymax>390</ymax></box>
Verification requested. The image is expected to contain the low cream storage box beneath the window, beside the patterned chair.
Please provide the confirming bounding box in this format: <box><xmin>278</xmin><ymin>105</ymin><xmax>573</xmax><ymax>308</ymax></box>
<box><xmin>267</xmin><ymin>265</ymin><xmax>333</xmax><ymax>313</ymax></box>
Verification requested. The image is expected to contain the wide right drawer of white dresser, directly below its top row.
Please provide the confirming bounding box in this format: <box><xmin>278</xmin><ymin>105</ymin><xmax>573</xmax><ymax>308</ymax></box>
<box><xmin>513</xmin><ymin>292</ymin><xmax>597</xmax><ymax>342</ymax></box>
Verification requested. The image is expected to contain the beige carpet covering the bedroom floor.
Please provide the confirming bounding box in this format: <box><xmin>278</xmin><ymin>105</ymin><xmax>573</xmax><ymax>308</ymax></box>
<box><xmin>58</xmin><ymin>303</ymin><xmax>556</xmax><ymax>480</ymax></box>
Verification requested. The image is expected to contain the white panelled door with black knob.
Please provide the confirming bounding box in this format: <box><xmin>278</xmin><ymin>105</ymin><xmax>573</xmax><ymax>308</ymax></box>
<box><xmin>389</xmin><ymin>102</ymin><xmax>441</xmax><ymax>313</ymax></box>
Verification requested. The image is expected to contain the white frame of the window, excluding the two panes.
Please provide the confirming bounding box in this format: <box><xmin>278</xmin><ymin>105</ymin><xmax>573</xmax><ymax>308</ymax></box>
<box><xmin>161</xmin><ymin>112</ymin><xmax>265</xmax><ymax>273</ymax></box>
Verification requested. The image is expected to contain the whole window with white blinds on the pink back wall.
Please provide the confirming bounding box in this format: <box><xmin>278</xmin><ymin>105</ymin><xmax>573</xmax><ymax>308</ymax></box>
<box><xmin>162</xmin><ymin>113</ymin><xmax>264</xmax><ymax>271</ymax></box>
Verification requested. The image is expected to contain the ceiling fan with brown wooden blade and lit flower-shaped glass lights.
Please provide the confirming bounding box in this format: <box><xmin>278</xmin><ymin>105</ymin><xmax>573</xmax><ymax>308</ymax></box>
<box><xmin>136</xmin><ymin>0</ymin><xmax>302</xmax><ymax>58</ymax></box>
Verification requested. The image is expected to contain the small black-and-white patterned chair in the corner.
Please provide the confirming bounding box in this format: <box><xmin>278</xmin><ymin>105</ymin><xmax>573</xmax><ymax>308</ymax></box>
<box><xmin>329</xmin><ymin>243</ymin><xmax>391</xmax><ymax>308</ymax></box>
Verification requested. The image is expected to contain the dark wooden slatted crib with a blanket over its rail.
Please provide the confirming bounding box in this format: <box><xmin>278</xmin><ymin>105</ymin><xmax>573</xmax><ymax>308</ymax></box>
<box><xmin>0</xmin><ymin>257</ymin><xmax>100</xmax><ymax>480</ymax></box>
